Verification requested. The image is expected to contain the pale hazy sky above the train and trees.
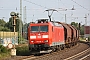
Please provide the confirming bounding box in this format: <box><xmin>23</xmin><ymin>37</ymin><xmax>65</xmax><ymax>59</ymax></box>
<box><xmin>0</xmin><ymin>0</ymin><xmax>90</xmax><ymax>25</ymax></box>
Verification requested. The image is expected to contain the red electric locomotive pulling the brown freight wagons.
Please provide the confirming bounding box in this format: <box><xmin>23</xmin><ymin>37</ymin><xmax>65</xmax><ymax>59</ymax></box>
<box><xmin>28</xmin><ymin>19</ymin><xmax>65</xmax><ymax>53</ymax></box>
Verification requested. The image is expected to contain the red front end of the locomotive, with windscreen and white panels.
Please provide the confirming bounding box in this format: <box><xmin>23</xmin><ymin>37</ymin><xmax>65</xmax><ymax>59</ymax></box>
<box><xmin>28</xmin><ymin>18</ymin><xmax>49</xmax><ymax>51</ymax></box>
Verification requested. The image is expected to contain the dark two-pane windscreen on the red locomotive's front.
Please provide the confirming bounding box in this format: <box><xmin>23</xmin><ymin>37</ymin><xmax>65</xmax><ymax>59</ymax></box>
<box><xmin>31</xmin><ymin>25</ymin><xmax>48</xmax><ymax>32</ymax></box>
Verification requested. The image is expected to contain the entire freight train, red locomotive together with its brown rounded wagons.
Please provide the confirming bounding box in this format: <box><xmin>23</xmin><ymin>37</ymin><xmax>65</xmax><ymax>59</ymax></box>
<box><xmin>28</xmin><ymin>19</ymin><xmax>78</xmax><ymax>54</ymax></box>
